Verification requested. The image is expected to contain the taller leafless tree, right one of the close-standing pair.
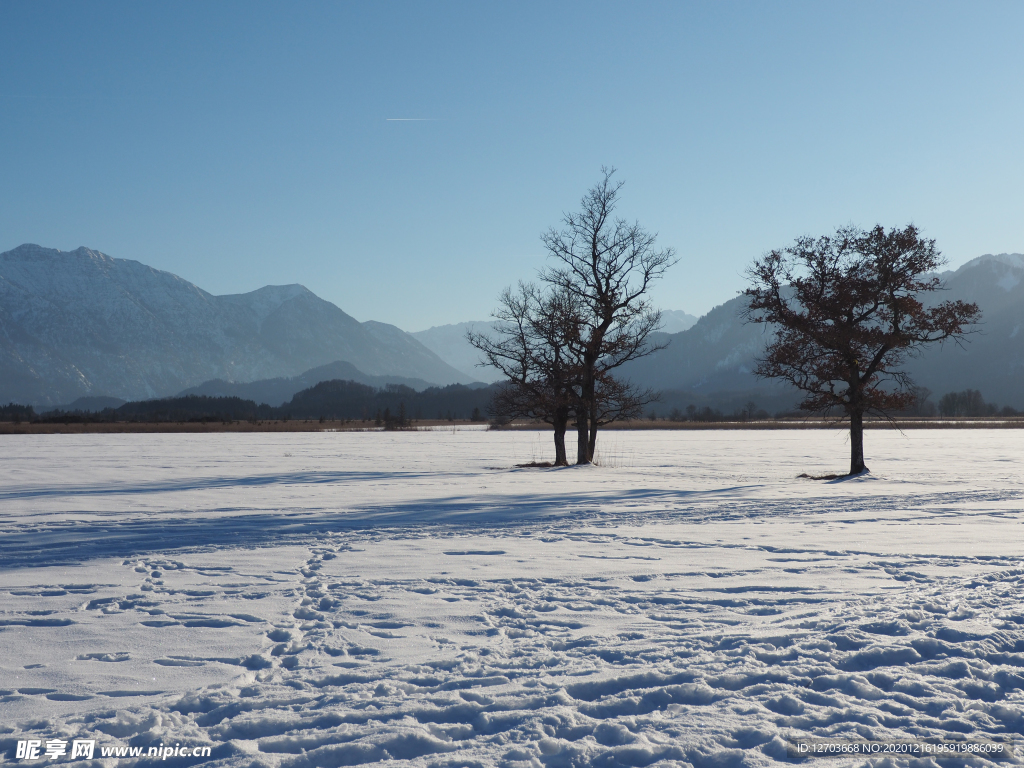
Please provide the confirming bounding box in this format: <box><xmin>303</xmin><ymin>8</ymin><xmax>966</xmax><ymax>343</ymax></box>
<box><xmin>541</xmin><ymin>168</ymin><xmax>676</xmax><ymax>464</ymax></box>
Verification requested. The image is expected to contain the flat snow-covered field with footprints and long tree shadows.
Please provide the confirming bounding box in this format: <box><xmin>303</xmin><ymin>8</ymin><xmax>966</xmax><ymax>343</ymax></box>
<box><xmin>0</xmin><ymin>430</ymin><xmax>1024</xmax><ymax>768</ymax></box>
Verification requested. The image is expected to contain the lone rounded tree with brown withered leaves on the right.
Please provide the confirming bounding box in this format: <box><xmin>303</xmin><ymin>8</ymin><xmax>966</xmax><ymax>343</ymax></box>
<box><xmin>744</xmin><ymin>224</ymin><xmax>981</xmax><ymax>474</ymax></box>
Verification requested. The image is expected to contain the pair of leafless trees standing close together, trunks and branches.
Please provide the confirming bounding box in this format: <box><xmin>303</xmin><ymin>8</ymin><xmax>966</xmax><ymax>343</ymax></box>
<box><xmin>467</xmin><ymin>168</ymin><xmax>676</xmax><ymax>465</ymax></box>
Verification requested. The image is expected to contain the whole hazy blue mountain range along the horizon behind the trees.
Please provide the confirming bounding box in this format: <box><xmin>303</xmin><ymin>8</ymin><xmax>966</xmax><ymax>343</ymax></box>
<box><xmin>0</xmin><ymin>245</ymin><xmax>1024</xmax><ymax>410</ymax></box>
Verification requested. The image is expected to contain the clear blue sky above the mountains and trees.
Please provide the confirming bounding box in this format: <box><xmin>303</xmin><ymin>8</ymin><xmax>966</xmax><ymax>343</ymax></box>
<box><xmin>0</xmin><ymin>0</ymin><xmax>1024</xmax><ymax>331</ymax></box>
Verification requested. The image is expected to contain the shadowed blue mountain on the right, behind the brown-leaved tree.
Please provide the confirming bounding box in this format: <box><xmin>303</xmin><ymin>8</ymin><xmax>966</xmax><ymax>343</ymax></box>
<box><xmin>621</xmin><ymin>254</ymin><xmax>1024</xmax><ymax>410</ymax></box>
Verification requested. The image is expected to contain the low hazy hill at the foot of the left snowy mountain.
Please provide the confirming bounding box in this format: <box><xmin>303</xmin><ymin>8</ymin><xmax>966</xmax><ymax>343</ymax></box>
<box><xmin>176</xmin><ymin>360</ymin><xmax>431</xmax><ymax>410</ymax></box>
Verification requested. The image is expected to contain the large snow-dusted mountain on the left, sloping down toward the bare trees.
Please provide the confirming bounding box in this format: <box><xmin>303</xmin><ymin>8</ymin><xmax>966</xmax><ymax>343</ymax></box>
<box><xmin>0</xmin><ymin>245</ymin><xmax>468</xmax><ymax>406</ymax></box>
